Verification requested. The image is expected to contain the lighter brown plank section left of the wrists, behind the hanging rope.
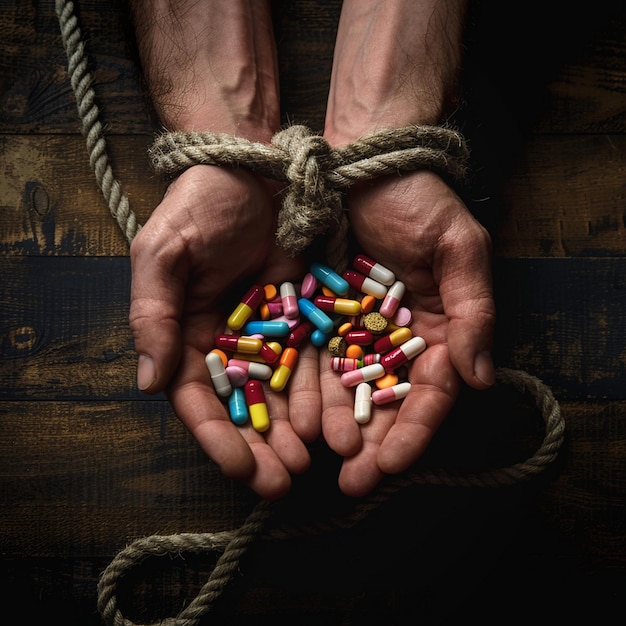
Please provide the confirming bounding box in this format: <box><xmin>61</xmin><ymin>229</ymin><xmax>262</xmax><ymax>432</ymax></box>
<box><xmin>0</xmin><ymin>134</ymin><xmax>165</xmax><ymax>256</ymax></box>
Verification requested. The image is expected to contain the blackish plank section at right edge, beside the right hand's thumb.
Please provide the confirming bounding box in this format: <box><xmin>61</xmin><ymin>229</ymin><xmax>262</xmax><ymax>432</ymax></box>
<box><xmin>495</xmin><ymin>257</ymin><xmax>626</xmax><ymax>400</ymax></box>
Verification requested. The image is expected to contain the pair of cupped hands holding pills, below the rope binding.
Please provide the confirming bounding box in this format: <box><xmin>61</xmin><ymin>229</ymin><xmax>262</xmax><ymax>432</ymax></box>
<box><xmin>130</xmin><ymin>165</ymin><xmax>495</xmax><ymax>499</ymax></box>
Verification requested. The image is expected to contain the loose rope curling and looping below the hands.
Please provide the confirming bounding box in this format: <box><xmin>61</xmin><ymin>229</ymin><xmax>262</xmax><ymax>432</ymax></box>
<box><xmin>98</xmin><ymin>368</ymin><xmax>565</xmax><ymax>626</ymax></box>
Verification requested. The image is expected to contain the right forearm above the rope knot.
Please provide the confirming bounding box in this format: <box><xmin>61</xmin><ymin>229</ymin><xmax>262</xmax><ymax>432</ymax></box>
<box><xmin>324</xmin><ymin>0</ymin><xmax>467</xmax><ymax>145</ymax></box>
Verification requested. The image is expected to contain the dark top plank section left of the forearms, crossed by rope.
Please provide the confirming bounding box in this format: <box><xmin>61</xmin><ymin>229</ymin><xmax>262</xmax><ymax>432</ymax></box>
<box><xmin>0</xmin><ymin>0</ymin><xmax>151</xmax><ymax>134</ymax></box>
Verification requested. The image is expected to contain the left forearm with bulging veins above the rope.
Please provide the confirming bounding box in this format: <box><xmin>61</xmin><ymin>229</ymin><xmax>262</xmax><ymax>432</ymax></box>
<box><xmin>131</xmin><ymin>0</ymin><xmax>280</xmax><ymax>141</ymax></box>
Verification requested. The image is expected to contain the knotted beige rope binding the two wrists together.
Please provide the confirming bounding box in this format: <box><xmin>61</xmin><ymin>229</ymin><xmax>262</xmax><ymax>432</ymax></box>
<box><xmin>149</xmin><ymin>125</ymin><xmax>469</xmax><ymax>271</ymax></box>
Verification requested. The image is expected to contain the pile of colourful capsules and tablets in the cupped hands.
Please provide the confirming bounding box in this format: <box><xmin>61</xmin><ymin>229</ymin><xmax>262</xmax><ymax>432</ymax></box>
<box><xmin>205</xmin><ymin>254</ymin><xmax>426</xmax><ymax>432</ymax></box>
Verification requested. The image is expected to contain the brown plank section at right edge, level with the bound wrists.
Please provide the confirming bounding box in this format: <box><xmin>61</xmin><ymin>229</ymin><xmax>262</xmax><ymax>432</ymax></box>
<box><xmin>496</xmin><ymin>133</ymin><xmax>626</xmax><ymax>257</ymax></box>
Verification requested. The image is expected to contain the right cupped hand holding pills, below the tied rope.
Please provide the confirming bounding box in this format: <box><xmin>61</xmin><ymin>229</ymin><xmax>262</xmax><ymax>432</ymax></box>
<box><xmin>320</xmin><ymin>171</ymin><xmax>495</xmax><ymax>496</ymax></box>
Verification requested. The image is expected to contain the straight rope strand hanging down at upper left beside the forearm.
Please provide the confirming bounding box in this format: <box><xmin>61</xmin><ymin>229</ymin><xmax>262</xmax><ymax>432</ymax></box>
<box><xmin>56</xmin><ymin>0</ymin><xmax>141</xmax><ymax>243</ymax></box>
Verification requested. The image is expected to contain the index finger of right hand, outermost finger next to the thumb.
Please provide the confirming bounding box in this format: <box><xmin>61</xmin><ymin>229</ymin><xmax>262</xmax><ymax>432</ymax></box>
<box><xmin>377</xmin><ymin>344</ymin><xmax>461</xmax><ymax>474</ymax></box>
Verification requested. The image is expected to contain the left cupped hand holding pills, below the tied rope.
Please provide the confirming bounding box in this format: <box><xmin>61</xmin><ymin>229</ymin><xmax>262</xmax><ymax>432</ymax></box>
<box><xmin>129</xmin><ymin>165</ymin><xmax>321</xmax><ymax>499</ymax></box>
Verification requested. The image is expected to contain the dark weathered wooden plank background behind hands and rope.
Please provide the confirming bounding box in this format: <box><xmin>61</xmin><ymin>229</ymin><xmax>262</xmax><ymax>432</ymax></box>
<box><xmin>0</xmin><ymin>0</ymin><xmax>626</xmax><ymax>626</ymax></box>
